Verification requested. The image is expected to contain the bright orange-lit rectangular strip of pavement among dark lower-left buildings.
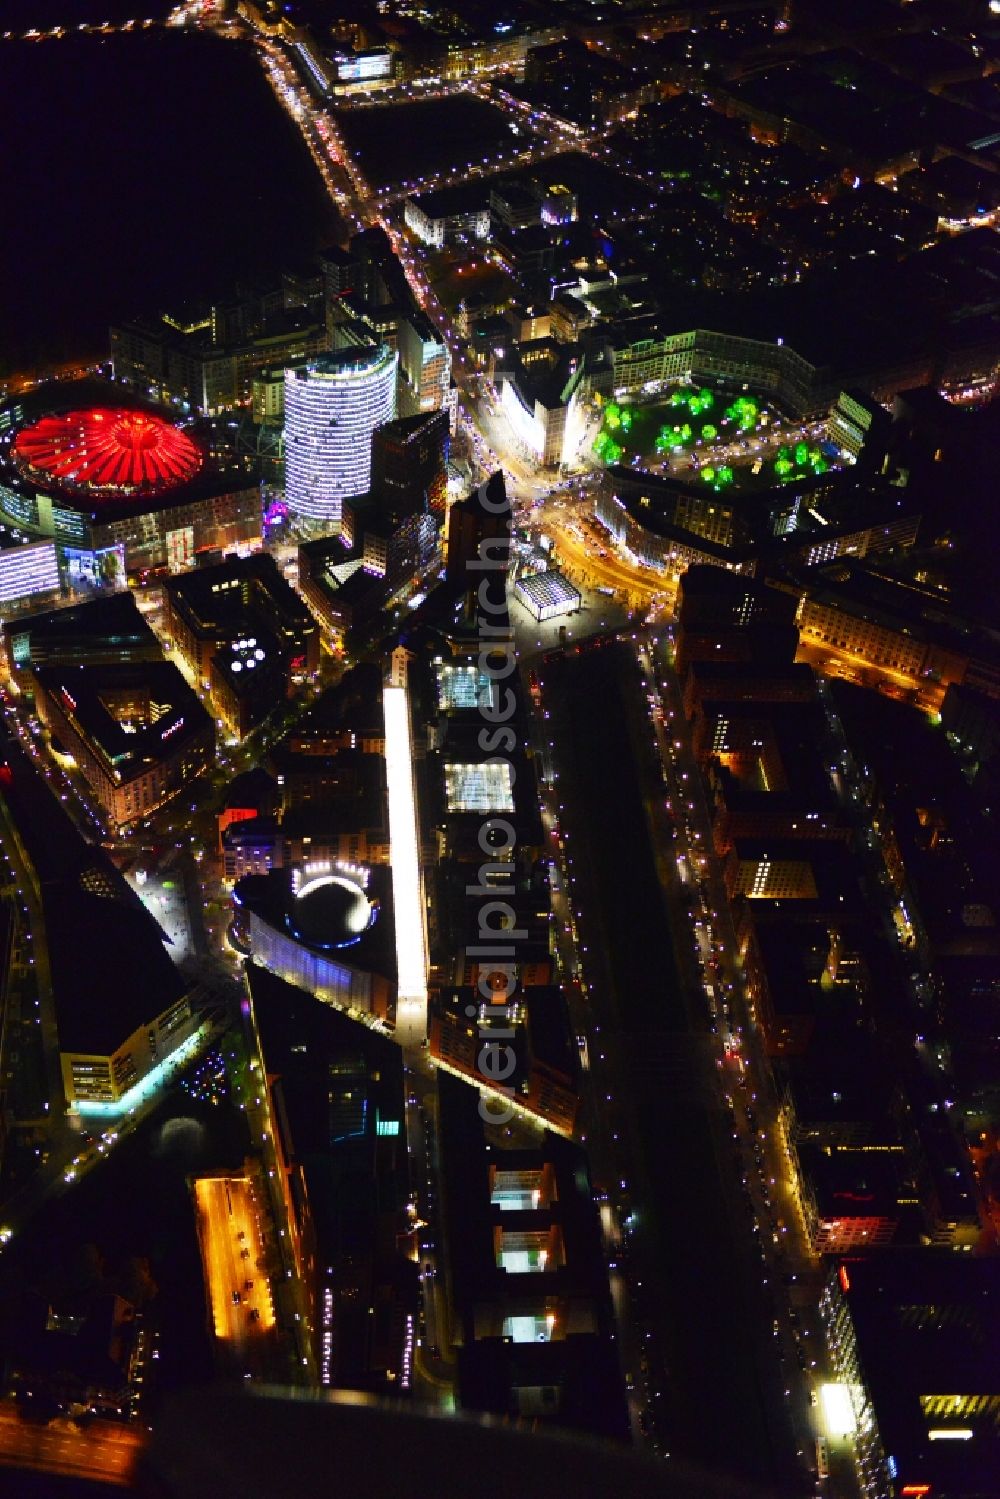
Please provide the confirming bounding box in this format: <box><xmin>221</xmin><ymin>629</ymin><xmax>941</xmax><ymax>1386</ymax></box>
<box><xmin>195</xmin><ymin>1177</ymin><xmax>274</xmax><ymax>1375</ymax></box>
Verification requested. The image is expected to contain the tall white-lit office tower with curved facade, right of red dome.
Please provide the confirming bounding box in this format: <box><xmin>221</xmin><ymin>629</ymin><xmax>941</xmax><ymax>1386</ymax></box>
<box><xmin>285</xmin><ymin>343</ymin><xmax>396</xmax><ymax>535</ymax></box>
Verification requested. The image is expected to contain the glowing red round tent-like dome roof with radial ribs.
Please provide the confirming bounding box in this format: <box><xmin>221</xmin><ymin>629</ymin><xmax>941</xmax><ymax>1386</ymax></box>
<box><xmin>13</xmin><ymin>406</ymin><xmax>201</xmax><ymax>493</ymax></box>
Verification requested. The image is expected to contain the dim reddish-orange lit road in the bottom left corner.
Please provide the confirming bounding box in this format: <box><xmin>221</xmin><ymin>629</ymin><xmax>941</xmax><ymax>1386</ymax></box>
<box><xmin>0</xmin><ymin>1402</ymin><xmax>145</xmax><ymax>1487</ymax></box>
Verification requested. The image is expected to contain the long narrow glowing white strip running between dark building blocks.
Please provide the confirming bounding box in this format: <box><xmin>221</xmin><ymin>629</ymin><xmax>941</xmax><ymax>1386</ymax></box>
<box><xmin>382</xmin><ymin>687</ymin><xmax>427</xmax><ymax>1046</ymax></box>
